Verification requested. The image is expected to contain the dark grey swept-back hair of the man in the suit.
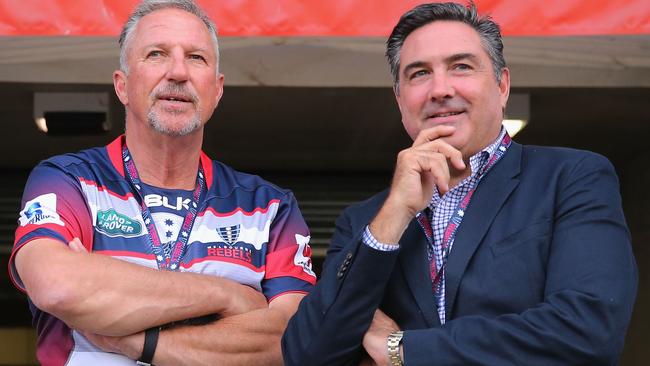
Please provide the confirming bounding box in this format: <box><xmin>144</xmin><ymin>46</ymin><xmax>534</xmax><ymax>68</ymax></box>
<box><xmin>386</xmin><ymin>1</ymin><xmax>507</xmax><ymax>94</ymax></box>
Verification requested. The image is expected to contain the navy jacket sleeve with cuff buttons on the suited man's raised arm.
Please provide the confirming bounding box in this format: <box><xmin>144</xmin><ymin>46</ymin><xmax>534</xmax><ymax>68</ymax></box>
<box><xmin>282</xmin><ymin>199</ymin><xmax>398</xmax><ymax>366</ymax></box>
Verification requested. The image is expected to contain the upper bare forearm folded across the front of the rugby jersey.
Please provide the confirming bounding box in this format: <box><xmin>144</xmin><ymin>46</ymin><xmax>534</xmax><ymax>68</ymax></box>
<box><xmin>16</xmin><ymin>239</ymin><xmax>264</xmax><ymax>335</ymax></box>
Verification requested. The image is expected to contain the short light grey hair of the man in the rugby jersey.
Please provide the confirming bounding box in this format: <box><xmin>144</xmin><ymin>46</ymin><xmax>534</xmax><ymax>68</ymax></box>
<box><xmin>119</xmin><ymin>0</ymin><xmax>220</xmax><ymax>74</ymax></box>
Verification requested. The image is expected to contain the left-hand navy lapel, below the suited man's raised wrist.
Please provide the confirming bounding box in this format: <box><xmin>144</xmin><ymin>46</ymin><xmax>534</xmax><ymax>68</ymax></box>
<box><xmin>399</xmin><ymin>220</ymin><xmax>440</xmax><ymax>327</ymax></box>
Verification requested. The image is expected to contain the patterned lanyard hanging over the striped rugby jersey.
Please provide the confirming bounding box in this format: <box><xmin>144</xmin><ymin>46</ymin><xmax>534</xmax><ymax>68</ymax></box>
<box><xmin>122</xmin><ymin>144</ymin><xmax>205</xmax><ymax>271</ymax></box>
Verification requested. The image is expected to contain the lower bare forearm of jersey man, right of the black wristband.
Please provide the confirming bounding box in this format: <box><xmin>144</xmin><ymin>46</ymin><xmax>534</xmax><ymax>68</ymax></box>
<box><xmin>153</xmin><ymin>294</ymin><xmax>304</xmax><ymax>366</ymax></box>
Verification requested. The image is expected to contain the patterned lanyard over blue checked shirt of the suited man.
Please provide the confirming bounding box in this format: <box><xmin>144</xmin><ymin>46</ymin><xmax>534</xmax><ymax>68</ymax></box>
<box><xmin>417</xmin><ymin>133</ymin><xmax>512</xmax><ymax>298</ymax></box>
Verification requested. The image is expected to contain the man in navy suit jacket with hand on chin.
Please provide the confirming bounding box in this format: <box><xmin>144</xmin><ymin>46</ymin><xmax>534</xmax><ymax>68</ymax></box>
<box><xmin>282</xmin><ymin>3</ymin><xmax>637</xmax><ymax>365</ymax></box>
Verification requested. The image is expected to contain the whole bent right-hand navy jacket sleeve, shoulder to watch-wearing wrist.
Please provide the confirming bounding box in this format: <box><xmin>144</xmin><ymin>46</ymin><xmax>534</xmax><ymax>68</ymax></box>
<box><xmin>403</xmin><ymin>154</ymin><xmax>638</xmax><ymax>366</ymax></box>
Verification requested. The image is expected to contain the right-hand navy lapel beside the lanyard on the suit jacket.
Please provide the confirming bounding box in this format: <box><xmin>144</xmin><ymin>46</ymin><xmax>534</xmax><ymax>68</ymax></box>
<box><xmin>445</xmin><ymin>142</ymin><xmax>522</xmax><ymax>319</ymax></box>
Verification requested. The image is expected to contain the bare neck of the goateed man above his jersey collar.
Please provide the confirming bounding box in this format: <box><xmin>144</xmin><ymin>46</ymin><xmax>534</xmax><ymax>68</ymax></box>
<box><xmin>126</xmin><ymin>128</ymin><xmax>203</xmax><ymax>189</ymax></box>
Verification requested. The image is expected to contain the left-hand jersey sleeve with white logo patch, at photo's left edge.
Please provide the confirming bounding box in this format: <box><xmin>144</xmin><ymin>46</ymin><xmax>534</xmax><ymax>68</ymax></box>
<box><xmin>9</xmin><ymin>162</ymin><xmax>93</xmax><ymax>291</ymax></box>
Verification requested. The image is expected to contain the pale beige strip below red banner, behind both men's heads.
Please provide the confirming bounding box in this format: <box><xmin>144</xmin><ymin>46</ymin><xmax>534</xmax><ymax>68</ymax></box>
<box><xmin>0</xmin><ymin>35</ymin><xmax>650</xmax><ymax>87</ymax></box>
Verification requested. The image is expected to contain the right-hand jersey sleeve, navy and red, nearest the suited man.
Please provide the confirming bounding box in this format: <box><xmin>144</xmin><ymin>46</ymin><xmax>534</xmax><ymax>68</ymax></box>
<box><xmin>262</xmin><ymin>193</ymin><xmax>316</xmax><ymax>301</ymax></box>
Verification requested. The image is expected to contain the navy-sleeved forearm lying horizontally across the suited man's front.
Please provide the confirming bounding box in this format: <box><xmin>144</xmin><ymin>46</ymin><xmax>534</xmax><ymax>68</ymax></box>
<box><xmin>403</xmin><ymin>291</ymin><xmax>630</xmax><ymax>366</ymax></box>
